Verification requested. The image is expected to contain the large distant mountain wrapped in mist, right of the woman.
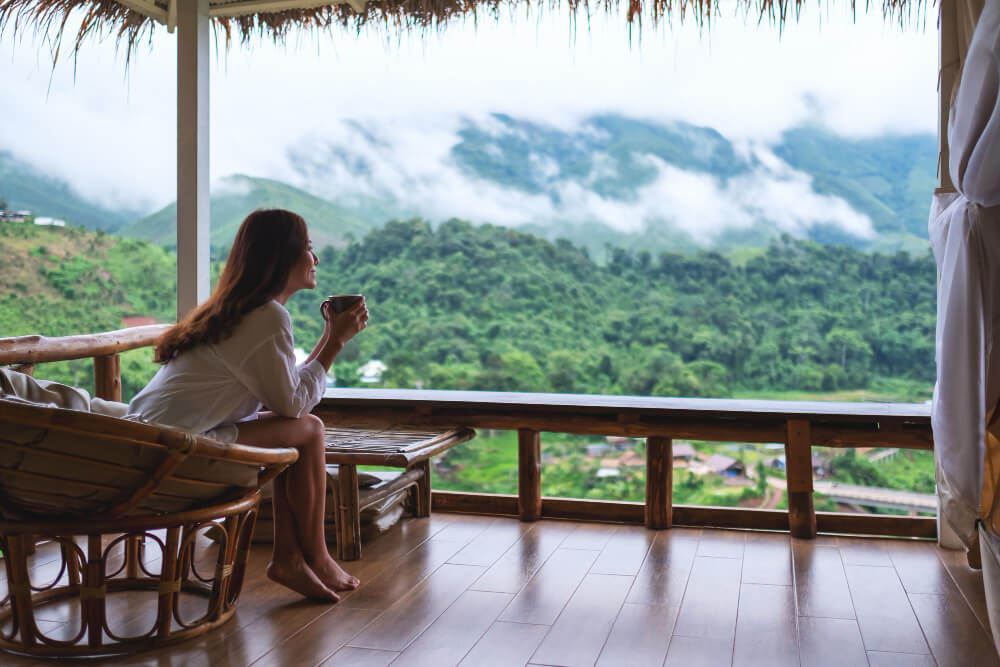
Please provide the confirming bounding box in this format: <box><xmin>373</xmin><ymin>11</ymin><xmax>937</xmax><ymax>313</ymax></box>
<box><xmin>287</xmin><ymin>114</ymin><xmax>937</xmax><ymax>254</ymax></box>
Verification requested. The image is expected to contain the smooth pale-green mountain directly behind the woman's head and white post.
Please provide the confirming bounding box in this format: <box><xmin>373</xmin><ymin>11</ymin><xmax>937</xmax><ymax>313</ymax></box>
<box><xmin>119</xmin><ymin>174</ymin><xmax>372</xmax><ymax>248</ymax></box>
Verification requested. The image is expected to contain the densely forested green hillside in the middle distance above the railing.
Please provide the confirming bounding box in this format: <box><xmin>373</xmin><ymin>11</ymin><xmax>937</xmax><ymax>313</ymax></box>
<box><xmin>0</xmin><ymin>220</ymin><xmax>935</xmax><ymax>400</ymax></box>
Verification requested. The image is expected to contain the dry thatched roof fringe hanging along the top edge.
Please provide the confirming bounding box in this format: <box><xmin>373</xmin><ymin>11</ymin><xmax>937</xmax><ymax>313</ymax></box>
<box><xmin>0</xmin><ymin>0</ymin><xmax>924</xmax><ymax>52</ymax></box>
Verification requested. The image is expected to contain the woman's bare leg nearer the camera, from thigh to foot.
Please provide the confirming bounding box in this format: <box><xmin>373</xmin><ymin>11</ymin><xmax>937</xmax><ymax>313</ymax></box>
<box><xmin>237</xmin><ymin>417</ymin><xmax>340</xmax><ymax>602</ymax></box>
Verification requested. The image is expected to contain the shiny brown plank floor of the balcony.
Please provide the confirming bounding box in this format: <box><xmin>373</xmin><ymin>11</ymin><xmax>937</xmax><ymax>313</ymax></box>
<box><xmin>0</xmin><ymin>513</ymin><xmax>1000</xmax><ymax>667</ymax></box>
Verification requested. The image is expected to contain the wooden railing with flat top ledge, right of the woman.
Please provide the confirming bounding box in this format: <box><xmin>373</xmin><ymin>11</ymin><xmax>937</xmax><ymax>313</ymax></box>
<box><xmin>315</xmin><ymin>389</ymin><xmax>937</xmax><ymax>538</ymax></box>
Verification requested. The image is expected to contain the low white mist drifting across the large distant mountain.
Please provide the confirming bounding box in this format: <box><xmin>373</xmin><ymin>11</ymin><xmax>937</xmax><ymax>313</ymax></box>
<box><xmin>289</xmin><ymin>116</ymin><xmax>875</xmax><ymax>244</ymax></box>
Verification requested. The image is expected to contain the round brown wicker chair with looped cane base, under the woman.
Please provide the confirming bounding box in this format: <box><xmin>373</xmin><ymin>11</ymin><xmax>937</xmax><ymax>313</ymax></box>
<box><xmin>0</xmin><ymin>334</ymin><xmax>298</xmax><ymax>662</ymax></box>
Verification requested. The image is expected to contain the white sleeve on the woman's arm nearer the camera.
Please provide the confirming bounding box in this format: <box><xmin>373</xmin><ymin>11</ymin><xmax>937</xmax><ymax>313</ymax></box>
<box><xmin>237</xmin><ymin>323</ymin><xmax>326</xmax><ymax>418</ymax></box>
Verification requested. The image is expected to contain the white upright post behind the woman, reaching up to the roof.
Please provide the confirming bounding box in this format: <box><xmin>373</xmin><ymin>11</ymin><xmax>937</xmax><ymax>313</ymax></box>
<box><xmin>176</xmin><ymin>0</ymin><xmax>210</xmax><ymax>319</ymax></box>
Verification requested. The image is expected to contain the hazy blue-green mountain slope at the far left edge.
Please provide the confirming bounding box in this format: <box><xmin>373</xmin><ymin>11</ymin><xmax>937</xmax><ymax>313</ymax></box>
<box><xmin>0</xmin><ymin>151</ymin><xmax>136</xmax><ymax>230</ymax></box>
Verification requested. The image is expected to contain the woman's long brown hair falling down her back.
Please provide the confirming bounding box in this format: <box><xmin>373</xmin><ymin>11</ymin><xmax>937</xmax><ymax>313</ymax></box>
<box><xmin>154</xmin><ymin>208</ymin><xmax>309</xmax><ymax>364</ymax></box>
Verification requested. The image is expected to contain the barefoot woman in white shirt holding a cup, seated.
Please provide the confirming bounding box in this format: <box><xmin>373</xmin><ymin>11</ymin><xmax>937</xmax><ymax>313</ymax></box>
<box><xmin>129</xmin><ymin>209</ymin><xmax>368</xmax><ymax>601</ymax></box>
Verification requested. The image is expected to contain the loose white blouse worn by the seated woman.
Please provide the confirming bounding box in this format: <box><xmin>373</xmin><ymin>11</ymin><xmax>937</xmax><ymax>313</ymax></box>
<box><xmin>128</xmin><ymin>301</ymin><xmax>326</xmax><ymax>442</ymax></box>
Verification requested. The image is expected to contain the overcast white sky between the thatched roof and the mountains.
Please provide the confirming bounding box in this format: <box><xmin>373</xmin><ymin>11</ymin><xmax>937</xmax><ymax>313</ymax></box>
<box><xmin>0</xmin><ymin>2</ymin><xmax>937</xmax><ymax>235</ymax></box>
